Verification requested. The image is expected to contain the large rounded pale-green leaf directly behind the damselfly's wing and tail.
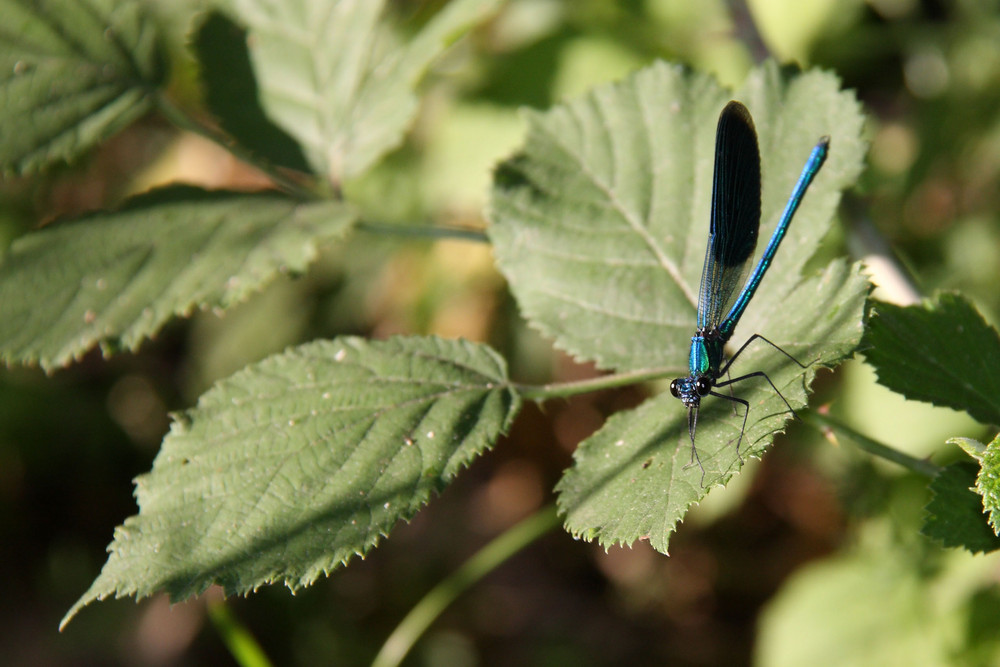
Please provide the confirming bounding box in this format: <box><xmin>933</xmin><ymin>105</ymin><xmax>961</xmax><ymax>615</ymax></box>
<box><xmin>489</xmin><ymin>63</ymin><xmax>865</xmax><ymax>371</ymax></box>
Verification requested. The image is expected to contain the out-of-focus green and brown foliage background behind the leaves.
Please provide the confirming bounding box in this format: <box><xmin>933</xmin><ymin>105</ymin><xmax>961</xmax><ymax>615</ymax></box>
<box><xmin>0</xmin><ymin>0</ymin><xmax>1000</xmax><ymax>666</ymax></box>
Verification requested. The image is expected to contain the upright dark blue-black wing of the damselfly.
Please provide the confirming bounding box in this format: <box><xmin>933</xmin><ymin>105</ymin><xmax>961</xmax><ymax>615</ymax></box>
<box><xmin>698</xmin><ymin>101</ymin><xmax>760</xmax><ymax>330</ymax></box>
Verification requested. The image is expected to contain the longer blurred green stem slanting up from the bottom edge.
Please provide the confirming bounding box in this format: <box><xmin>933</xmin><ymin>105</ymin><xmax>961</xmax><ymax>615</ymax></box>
<box><xmin>372</xmin><ymin>505</ymin><xmax>559</xmax><ymax>667</ymax></box>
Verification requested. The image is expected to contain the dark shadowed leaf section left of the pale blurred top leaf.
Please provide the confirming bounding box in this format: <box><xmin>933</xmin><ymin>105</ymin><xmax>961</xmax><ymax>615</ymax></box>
<box><xmin>193</xmin><ymin>12</ymin><xmax>309</xmax><ymax>171</ymax></box>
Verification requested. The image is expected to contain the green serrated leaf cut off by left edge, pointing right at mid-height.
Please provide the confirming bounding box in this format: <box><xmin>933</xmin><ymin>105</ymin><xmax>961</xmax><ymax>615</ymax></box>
<box><xmin>0</xmin><ymin>186</ymin><xmax>354</xmax><ymax>369</ymax></box>
